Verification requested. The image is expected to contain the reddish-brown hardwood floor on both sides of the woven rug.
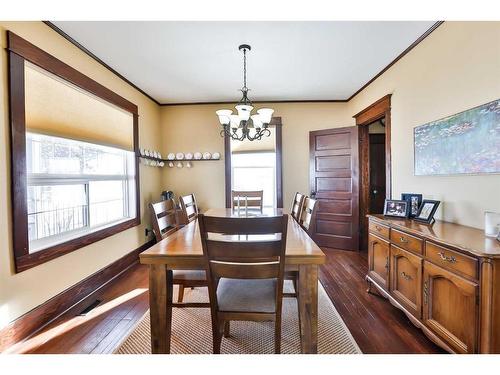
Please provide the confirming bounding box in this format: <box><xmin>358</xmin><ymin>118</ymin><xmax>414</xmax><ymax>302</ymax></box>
<box><xmin>9</xmin><ymin>249</ymin><xmax>443</xmax><ymax>353</ymax></box>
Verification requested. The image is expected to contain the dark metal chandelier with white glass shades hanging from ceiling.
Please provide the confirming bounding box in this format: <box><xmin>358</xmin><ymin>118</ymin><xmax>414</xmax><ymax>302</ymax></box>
<box><xmin>215</xmin><ymin>44</ymin><xmax>274</xmax><ymax>141</ymax></box>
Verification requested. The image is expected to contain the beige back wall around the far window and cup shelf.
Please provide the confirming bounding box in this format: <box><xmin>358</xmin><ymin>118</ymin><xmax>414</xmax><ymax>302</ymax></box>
<box><xmin>161</xmin><ymin>103</ymin><xmax>353</xmax><ymax>209</ymax></box>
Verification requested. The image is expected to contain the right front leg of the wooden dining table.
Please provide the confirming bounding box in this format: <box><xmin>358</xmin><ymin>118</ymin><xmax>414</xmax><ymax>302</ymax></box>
<box><xmin>298</xmin><ymin>264</ymin><xmax>318</xmax><ymax>354</ymax></box>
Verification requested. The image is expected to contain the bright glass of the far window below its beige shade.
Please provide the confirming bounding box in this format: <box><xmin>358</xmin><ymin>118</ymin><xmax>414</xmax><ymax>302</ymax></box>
<box><xmin>231</xmin><ymin>152</ymin><xmax>276</xmax><ymax>207</ymax></box>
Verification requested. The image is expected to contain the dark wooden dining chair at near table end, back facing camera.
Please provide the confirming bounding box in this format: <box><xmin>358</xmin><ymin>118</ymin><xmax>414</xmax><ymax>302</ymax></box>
<box><xmin>198</xmin><ymin>215</ymin><xmax>288</xmax><ymax>353</ymax></box>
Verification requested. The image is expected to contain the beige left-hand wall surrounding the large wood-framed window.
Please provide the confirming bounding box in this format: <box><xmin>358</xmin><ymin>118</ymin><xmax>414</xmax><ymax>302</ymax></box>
<box><xmin>0</xmin><ymin>22</ymin><xmax>161</xmax><ymax>328</ymax></box>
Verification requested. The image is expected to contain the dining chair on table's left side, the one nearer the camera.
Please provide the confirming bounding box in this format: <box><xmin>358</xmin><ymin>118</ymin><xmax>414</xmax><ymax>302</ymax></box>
<box><xmin>149</xmin><ymin>199</ymin><xmax>209</xmax><ymax>307</ymax></box>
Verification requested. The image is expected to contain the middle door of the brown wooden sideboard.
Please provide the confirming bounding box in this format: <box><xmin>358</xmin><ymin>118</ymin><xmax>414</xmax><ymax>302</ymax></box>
<box><xmin>390</xmin><ymin>245</ymin><xmax>422</xmax><ymax>319</ymax></box>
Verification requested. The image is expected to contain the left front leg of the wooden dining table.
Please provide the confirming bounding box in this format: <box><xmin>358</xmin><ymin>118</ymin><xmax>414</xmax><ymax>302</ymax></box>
<box><xmin>149</xmin><ymin>264</ymin><xmax>173</xmax><ymax>354</ymax></box>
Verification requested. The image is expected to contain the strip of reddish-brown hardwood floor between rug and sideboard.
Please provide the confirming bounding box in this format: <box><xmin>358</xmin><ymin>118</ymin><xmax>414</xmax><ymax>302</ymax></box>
<box><xmin>319</xmin><ymin>248</ymin><xmax>444</xmax><ymax>354</ymax></box>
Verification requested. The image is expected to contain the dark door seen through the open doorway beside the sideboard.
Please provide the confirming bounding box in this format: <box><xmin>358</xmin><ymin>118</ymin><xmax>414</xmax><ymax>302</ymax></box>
<box><xmin>369</xmin><ymin>134</ymin><xmax>385</xmax><ymax>214</ymax></box>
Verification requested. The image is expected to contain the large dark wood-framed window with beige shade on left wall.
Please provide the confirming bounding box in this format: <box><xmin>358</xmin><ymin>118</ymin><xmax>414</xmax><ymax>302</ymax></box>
<box><xmin>7</xmin><ymin>32</ymin><xmax>140</xmax><ymax>272</ymax></box>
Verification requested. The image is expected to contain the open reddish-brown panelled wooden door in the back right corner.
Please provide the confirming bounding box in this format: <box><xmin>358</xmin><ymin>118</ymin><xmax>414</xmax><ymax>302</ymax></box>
<box><xmin>309</xmin><ymin>126</ymin><xmax>359</xmax><ymax>250</ymax></box>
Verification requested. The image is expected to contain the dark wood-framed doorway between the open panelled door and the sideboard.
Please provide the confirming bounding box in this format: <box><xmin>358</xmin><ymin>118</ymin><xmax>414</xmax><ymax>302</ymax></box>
<box><xmin>354</xmin><ymin>94</ymin><xmax>391</xmax><ymax>250</ymax></box>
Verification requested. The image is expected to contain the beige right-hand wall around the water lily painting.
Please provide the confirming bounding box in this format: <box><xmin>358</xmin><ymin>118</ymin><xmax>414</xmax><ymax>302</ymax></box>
<box><xmin>348</xmin><ymin>22</ymin><xmax>500</xmax><ymax>228</ymax></box>
